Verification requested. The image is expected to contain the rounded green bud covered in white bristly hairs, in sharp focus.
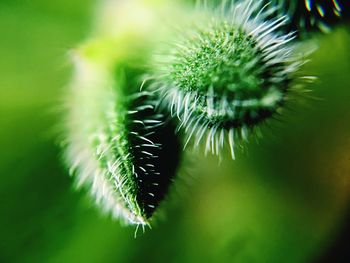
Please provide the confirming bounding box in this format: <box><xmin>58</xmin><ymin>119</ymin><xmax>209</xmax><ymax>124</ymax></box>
<box><xmin>153</xmin><ymin>0</ymin><xmax>302</xmax><ymax>157</ymax></box>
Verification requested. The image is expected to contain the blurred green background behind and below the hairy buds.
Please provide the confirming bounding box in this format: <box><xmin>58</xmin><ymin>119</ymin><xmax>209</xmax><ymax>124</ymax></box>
<box><xmin>0</xmin><ymin>0</ymin><xmax>350</xmax><ymax>262</ymax></box>
